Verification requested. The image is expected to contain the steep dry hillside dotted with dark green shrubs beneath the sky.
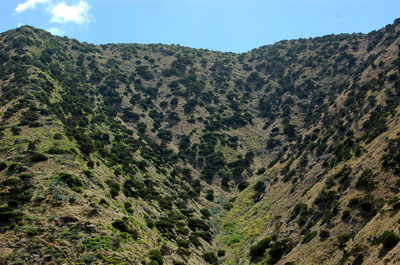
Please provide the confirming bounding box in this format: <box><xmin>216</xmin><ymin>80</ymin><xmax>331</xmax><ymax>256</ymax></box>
<box><xmin>0</xmin><ymin>20</ymin><xmax>400</xmax><ymax>265</ymax></box>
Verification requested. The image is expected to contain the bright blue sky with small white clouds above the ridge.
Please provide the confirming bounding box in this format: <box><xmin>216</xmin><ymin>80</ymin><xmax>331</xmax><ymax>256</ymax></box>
<box><xmin>0</xmin><ymin>0</ymin><xmax>400</xmax><ymax>52</ymax></box>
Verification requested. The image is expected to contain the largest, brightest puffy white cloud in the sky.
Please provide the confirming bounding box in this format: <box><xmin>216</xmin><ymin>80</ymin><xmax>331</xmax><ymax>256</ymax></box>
<box><xmin>50</xmin><ymin>1</ymin><xmax>90</xmax><ymax>24</ymax></box>
